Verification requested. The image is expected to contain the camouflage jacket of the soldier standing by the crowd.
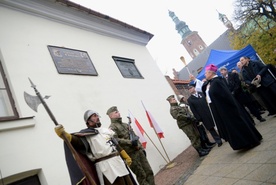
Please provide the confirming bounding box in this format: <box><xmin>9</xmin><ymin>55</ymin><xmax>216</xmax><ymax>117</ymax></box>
<box><xmin>170</xmin><ymin>103</ymin><xmax>196</xmax><ymax>128</ymax></box>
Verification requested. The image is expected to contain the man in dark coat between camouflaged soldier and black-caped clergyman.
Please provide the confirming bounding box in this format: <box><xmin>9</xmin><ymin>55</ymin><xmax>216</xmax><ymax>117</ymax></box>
<box><xmin>187</xmin><ymin>83</ymin><xmax>222</xmax><ymax>147</ymax></box>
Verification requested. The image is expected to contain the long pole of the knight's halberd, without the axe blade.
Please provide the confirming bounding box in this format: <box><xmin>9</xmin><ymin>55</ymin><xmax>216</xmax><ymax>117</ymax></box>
<box><xmin>29</xmin><ymin>78</ymin><xmax>96</xmax><ymax>185</ymax></box>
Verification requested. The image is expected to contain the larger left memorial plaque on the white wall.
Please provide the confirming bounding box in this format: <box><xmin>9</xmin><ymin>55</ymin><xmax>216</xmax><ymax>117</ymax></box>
<box><xmin>48</xmin><ymin>46</ymin><xmax>98</xmax><ymax>76</ymax></box>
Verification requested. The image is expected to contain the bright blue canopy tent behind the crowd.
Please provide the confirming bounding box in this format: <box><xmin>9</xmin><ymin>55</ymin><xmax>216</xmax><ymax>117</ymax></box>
<box><xmin>196</xmin><ymin>44</ymin><xmax>258</xmax><ymax>80</ymax></box>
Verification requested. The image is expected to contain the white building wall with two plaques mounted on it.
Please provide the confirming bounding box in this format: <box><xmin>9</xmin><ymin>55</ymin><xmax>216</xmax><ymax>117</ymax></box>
<box><xmin>0</xmin><ymin>2</ymin><xmax>190</xmax><ymax>185</ymax></box>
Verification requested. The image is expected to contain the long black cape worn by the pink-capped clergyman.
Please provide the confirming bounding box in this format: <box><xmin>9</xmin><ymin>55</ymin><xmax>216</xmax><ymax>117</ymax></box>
<box><xmin>202</xmin><ymin>77</ymin><xmax>262</xmax><ymax>150</ymax></box>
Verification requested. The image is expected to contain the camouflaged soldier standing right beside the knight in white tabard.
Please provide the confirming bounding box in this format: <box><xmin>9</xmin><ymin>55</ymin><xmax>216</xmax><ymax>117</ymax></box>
<box><xmin>106</xmin><ymin>106</ymin><xmax>155</xmax><ymax>185</ymax></box>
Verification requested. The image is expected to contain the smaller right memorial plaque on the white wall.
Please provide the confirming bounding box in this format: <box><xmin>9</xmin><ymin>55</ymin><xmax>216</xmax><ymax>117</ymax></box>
<box><xmin>112</xmin><ymin>56</ymin><xmax>143</xmax><ymax>78</ymax></box>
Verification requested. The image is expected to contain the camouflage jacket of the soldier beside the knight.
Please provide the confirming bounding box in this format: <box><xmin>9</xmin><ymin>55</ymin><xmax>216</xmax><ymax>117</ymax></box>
<box><xmin>109</xmin><ymin>118</ymin><xmax>142</xmax><ymax>153</ymax></box>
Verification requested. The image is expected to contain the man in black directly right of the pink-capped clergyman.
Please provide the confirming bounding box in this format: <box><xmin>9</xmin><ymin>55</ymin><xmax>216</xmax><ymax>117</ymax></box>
<box><xmin>219</xmin><ymin>66</ymin><xmax>266</xmax><ymax>122</ymax></box>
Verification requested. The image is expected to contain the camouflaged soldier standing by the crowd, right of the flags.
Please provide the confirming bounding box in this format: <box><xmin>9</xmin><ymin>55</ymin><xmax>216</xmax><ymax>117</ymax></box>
<box><xmin>167</xmin><ymin>95</ymin><xmax>210</xmax><ymax>157</ymax></box>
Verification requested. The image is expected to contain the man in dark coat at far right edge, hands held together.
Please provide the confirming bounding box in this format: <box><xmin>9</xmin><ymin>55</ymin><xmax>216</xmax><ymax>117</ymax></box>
<box><xmin>240</xmin><ymin>56</ymin><xmax>276</xmax><ymax>115</ymax></box>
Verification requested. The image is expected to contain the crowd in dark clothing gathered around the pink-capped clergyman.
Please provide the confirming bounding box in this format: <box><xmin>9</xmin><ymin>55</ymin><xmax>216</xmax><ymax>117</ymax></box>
<box><xmin>167</xmin><ymin>56</ymin><xmax>276</xmax><ymax>156</ymax></box>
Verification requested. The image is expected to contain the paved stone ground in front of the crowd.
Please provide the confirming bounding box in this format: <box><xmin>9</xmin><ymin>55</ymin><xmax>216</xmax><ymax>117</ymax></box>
<box><xmin>155</xmin><ymin>113</ymin><xmax>276</xmax><ymax>185</ymax></box>
